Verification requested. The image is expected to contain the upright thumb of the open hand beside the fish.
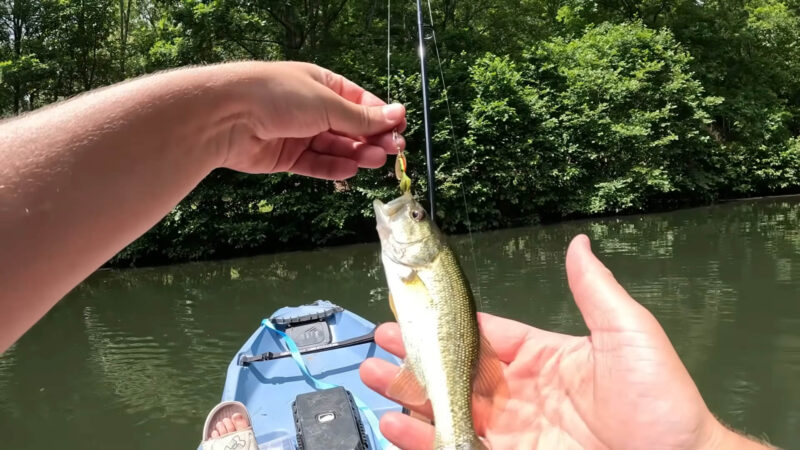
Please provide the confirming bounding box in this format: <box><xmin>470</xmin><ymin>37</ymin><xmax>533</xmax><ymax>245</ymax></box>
<box><xmin>567</xmin><ymin>234</ymin><xmax>661</xmax><ymax>334</ymax></box>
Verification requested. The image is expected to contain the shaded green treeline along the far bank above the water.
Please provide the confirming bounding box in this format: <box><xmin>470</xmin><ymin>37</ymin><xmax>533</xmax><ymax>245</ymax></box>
<box><xmin>0</xmin><ymin>0</ymin><xmax>800</xmax><ymax>264</ymax></box>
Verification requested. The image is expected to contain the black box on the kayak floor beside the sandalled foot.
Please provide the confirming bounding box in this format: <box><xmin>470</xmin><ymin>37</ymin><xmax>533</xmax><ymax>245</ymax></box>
<box><xmin>292</xmin><ymin>387</ymin><xmax>369</xmax><ymax>450</ymax></box>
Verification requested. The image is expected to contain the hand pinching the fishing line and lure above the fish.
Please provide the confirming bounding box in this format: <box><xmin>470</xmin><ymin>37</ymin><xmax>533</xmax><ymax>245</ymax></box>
<box><xmin>221</xmin><ymin>62</ymin><xmax>406</xmax><ymax>180</ymax></box>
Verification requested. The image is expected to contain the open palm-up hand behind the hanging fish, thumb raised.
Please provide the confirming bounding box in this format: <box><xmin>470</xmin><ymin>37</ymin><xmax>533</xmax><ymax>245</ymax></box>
<box><xmin>361</xmin><ymin>236</ymin><xmax>763</xmax><ymax>450</ymax></box>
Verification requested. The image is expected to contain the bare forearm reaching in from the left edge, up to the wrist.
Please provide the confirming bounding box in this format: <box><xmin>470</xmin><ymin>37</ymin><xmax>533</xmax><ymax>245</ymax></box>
<box><xmin>0</xmin><ymin>63</ymin><xmax>244</xmax><ymax>352</ymax></box>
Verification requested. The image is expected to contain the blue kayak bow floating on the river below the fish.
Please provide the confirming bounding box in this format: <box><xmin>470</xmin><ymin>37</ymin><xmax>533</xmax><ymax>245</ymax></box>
<box><xmin>216</xmin><ymin>300</ymin><xmax>402</xmax><ymax>450</ymax></box>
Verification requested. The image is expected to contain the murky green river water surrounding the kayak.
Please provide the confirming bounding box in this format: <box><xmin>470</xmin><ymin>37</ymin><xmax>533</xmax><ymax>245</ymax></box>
<box><xmin>0</xmin><ymin>197</ymin><xmax>800</xmax><ymax>449</ymax></box>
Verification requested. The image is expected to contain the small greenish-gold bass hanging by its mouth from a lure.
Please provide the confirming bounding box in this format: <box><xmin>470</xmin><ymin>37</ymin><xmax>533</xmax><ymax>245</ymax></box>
<box><xmin>373</xmin><ymin>191</ymin><xmax>503</xmax><ymax>450</ymax></box>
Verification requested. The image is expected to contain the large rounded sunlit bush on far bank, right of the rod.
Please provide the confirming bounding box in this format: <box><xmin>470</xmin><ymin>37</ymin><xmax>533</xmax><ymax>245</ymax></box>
<box><xmin>443</xmin><ymin>23</ymin><xmax>721</xmax><ymax>228</ymax></box>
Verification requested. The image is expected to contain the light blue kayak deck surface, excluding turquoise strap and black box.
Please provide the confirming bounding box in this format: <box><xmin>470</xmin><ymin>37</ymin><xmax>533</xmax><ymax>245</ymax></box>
<box><xmin>222</xmin><ymin>301</ymin><xmax>402</xmax><ymax>449</ymax></box>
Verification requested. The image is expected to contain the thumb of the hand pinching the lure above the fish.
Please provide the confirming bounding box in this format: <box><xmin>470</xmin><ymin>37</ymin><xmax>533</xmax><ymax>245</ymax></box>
<box><xmin>325</xmin><ymin>94</ymin><xmax>406</xmax><ymax>137</ymax></box>
